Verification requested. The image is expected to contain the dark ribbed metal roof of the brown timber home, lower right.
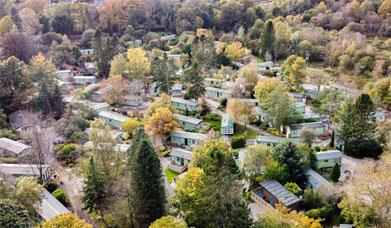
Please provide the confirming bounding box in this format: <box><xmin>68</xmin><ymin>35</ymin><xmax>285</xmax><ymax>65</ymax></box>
<box><xmin>259</xmin><ymin>180</ymin><xmax>300</xmax><ymax>207</ymax></box>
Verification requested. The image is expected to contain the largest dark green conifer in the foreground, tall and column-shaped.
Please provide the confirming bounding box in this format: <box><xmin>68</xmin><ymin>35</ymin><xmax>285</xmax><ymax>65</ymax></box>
<box><xmin>128</xmin><ymin>129</ymin><xmax>165</xmax><ymax>227</ymax></box>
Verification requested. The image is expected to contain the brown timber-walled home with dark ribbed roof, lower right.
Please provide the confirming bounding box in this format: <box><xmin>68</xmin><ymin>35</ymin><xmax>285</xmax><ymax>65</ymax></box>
<box><xmin>251</xmin><ymin>180</ymin><xmax>300</xmax><ymax>210</ymax></box>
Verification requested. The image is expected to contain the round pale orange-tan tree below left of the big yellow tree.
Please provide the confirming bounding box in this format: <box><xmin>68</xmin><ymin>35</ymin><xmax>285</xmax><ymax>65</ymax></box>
<box><xmin>100</xmin><ymin>75</ymin><xmax>129</xmax><ymax>104</ymax></box>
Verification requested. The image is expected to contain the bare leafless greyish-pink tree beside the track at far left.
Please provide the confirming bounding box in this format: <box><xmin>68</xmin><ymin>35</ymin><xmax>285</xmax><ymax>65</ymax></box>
<box><xmin>21</xmin><ymin>112</ymin><xmax>57</xmax><ymax>181</ymax></box>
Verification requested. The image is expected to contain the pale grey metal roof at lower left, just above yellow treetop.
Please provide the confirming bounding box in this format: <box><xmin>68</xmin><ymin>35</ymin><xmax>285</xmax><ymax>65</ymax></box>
<box><xmin>38</xmin><ymin>189</ymin><xmax>69</xmax><ymax>221</ymax></box>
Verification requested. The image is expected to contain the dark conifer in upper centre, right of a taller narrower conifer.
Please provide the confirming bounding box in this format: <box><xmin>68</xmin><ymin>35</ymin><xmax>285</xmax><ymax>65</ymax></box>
<box><xmin>184</xmin><ymin>63</ymin><xmax>205</xmax><ymax>99</ymax></box>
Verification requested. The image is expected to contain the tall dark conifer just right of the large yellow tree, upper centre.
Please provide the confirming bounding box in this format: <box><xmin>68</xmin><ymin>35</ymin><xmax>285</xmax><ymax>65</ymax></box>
<box><xmin>151</xmin><ymin>53</ymin><xmax>175</xmax><ymax>94</ymax></box>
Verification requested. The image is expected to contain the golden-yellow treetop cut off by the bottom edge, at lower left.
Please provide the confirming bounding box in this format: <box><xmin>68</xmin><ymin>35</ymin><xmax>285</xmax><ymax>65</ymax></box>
<box><xmin>41</xmin><ymin>212</ymin><xmax>93</xmax><ymax>228</ymax></box>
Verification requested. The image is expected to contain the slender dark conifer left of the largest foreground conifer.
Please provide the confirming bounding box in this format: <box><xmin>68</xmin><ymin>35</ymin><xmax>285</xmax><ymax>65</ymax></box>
<box><xmin>82</xmin><ymin>156</ymin><xmax>105</xmax><ymax>213</ymax></box>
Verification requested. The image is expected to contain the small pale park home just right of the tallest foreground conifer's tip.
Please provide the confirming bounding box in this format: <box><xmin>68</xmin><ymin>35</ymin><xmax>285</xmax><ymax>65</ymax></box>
<box><xmin>168</xmin><ymin>148</ymin><xmax>193</xmax><ymax>173</ymax></box>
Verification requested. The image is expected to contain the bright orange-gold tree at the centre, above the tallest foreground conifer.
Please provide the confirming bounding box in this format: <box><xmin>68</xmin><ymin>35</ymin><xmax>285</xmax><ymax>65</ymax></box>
<box><xmin>145</xmin><ymin>108</ymin><xmax>179</xmax><ymax>138</ymax></box>
